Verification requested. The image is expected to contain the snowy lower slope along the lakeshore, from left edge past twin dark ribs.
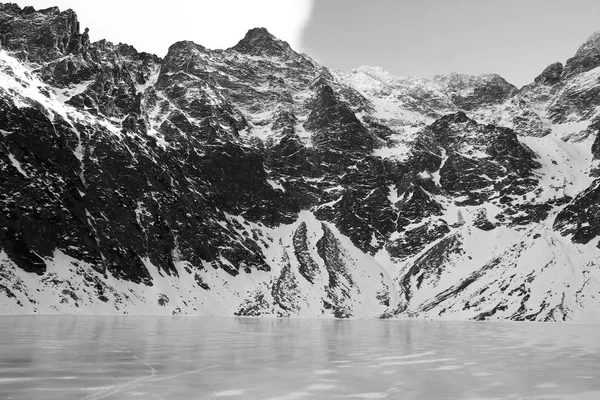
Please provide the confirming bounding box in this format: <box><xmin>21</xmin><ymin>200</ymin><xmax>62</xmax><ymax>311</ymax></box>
<box><xmin>0</xmin><ymin>211</ymin><xmax>398</xmax><ymax>317</ymax></box>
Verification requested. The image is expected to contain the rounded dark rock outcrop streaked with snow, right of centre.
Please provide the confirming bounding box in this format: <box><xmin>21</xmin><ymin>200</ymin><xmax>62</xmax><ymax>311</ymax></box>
<box><xmin>411</xmin><ymin>113</ymin><xmax>540</xmax><ymax>205</ymax></box>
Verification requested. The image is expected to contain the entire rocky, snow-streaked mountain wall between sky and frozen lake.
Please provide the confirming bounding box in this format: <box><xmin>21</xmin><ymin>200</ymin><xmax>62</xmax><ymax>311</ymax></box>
<box><xmin>0</xmin><ymin>4</ymin><xmax>600</xmax><ymax>320</ymax></box>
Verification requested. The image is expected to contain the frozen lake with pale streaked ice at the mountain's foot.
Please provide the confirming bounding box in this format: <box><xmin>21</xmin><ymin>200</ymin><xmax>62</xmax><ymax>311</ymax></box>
<box><xmin>0</xmin><ymin>316</ymin><xmax>600</xmax><ymax>400</ymax></box>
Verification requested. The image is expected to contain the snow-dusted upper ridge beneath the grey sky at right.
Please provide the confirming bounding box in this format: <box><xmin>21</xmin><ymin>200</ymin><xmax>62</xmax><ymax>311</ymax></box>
<box><xmin>335</xmin><ymin>32</ymin><xmax>600</xmax><ymax>151</ymax></box>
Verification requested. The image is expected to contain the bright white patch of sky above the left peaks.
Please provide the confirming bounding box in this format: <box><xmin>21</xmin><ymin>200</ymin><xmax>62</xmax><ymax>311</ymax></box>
<box><xmin>13</xmin><ymin>0</ymin><xmax>314</xmax><ymax>57</ymax></box>
